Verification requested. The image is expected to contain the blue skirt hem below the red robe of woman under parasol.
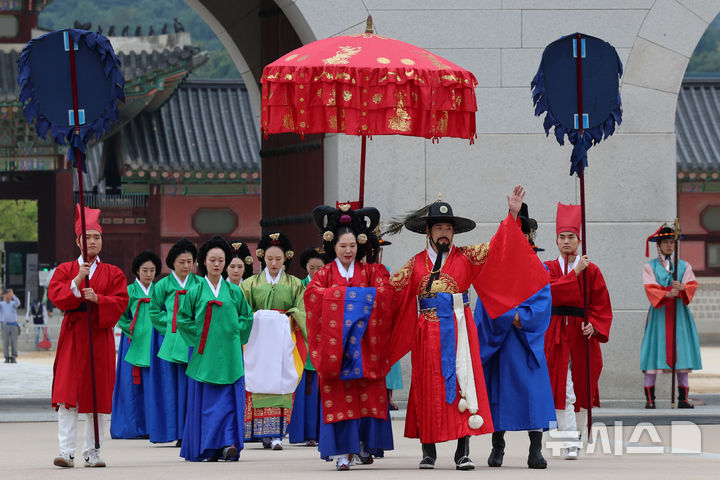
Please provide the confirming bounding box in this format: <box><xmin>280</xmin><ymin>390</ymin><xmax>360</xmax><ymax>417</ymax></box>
<box><xmin>318</xmin><ymin>405</ymin><xmax>394</xmax><ymax>460</ymax></box>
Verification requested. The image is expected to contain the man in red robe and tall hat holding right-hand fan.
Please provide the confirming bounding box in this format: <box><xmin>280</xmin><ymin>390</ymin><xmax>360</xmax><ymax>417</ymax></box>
<box><xmin>545</xmin><ymin>203</ymin><xmax>612</xmax><ymax>460</ymax></box>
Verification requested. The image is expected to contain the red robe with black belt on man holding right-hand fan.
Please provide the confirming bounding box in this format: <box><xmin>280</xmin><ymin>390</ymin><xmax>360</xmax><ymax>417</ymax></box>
<box><xmin>545</xmin><ymin>259</ymin><xmax>612</xmax><ymax>412</ymax></box>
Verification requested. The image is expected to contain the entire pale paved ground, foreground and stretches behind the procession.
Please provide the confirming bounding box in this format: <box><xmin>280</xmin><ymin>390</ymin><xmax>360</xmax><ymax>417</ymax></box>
<box><xmin>0</xmin><ymin>322</ymin><xmax>720</xmax><ymax>480</ymax></box>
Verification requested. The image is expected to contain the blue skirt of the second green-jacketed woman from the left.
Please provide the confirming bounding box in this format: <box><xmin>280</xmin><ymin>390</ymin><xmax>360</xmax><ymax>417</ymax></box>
<box><xmin>145</xmin><ymin>328</ymin><xmax>187</xmax><ymax>443</ymax></box>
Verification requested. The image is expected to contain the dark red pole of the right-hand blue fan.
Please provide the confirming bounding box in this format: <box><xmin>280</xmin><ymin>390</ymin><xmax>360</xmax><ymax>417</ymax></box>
<box><xmin>576</xmin><ymin>33</ymin><xmax>592</xmax><ymax>441</ymax></box>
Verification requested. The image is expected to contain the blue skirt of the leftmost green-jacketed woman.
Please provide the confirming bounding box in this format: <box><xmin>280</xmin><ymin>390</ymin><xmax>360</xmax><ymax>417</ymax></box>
<box><xmin>110</xmin><ymin>333</ymin><xmax>150</xmax><ymax>438</ymax></box>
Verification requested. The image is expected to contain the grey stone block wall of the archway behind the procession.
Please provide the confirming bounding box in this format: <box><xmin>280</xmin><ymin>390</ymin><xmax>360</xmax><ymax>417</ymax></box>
<box><xmin>186</xmin><ymin>0</ymin><xmax>720</xmax><ymax>398</ymax></box>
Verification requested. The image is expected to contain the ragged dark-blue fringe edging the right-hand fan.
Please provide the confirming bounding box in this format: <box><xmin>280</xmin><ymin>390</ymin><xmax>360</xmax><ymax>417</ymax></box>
<box><xmin>530</xmin><ymin>34</ymin><xmax>623</xmax><ymax>175</ymax></box>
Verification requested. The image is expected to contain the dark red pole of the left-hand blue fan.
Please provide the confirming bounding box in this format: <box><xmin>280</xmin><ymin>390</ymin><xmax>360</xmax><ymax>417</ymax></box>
<box><xmin>67</xmin><ymin>32</ymin><xmax>100</xmax><ymax>449</ymax></box>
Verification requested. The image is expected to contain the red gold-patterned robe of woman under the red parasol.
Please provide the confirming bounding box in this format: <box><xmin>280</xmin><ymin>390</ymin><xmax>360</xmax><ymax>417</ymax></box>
<box><xmin>305</xmin><ymin>261</ymin><xmax>393</xmax><ymax>423</ymax></box>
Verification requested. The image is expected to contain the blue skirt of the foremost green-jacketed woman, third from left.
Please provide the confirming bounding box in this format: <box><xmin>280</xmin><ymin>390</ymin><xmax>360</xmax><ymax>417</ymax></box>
<box><xmin>180</xmin><ymin>377</ymin><xmax>245</xmax><ymax>462</ymax></box>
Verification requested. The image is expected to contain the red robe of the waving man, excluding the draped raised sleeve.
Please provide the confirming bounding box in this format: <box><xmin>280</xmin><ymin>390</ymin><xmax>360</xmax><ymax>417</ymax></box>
<box><xmin>389</xmin><ymin>243</ymin><xmax>493</xmax><ymax>443</ymax></box>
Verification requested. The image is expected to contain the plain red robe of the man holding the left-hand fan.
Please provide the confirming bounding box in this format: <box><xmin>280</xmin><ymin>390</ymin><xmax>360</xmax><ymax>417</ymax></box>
<box><xmin>48</xmin><ymin>260</ymin><xmax>128</xmax><ymax>413</ymax></box>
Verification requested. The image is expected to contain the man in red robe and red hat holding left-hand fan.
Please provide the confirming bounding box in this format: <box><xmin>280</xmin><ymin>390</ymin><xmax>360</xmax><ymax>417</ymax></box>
<box><xmin>48</xmin><ymin>205</ymin><xmax>128</xmax><ymax>467</ymax></box>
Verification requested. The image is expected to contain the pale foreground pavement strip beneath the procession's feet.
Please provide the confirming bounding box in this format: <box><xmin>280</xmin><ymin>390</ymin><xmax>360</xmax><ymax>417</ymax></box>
<box><xmin>0</xmin><ymin>420</ymin><xmax>720</xmax><ymax>480</ymax></box>
